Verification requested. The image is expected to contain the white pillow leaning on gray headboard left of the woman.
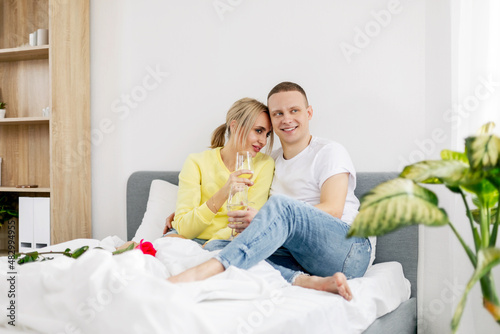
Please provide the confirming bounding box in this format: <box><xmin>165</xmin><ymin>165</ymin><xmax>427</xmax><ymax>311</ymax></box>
<box><xmin>132</xmin><ymin>180</ymin><xmax>178</xmax><ymax>242</ymax></box>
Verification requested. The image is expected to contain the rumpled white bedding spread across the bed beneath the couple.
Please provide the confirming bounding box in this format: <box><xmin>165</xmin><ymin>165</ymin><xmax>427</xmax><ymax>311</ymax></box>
<box><xmin>0</xmin><ymin>237</ymin><xmax>410</xmax><ymax>334</ymax></box>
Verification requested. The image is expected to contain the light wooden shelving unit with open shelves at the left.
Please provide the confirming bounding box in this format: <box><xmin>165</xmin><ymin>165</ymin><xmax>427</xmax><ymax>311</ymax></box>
<box><xmin>0</xmin><ymin>0</ymin><xmax>91</xmax><ymax>244</ymax></box>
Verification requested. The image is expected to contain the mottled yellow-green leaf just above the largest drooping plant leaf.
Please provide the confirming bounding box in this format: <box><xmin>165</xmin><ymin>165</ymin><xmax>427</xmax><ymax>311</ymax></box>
<box><xmin>400</xmin><ymin>160</ymin><xmax>483</xmax><ymax>190</ymax></box>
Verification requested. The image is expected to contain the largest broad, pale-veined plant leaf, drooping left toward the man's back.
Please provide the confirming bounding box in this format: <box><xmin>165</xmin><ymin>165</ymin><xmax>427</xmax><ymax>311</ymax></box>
<box><xmin>348</xmin><ymin>178</ymin><xmax>448</xmax><ymax>237</ymax></box>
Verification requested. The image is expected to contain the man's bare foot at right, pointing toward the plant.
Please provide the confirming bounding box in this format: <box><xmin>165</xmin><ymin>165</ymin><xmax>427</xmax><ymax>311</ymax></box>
<box><xmin>293</xmin><ymin>273</ymin><xmax>352</xmax><ymax>301</ymax></box>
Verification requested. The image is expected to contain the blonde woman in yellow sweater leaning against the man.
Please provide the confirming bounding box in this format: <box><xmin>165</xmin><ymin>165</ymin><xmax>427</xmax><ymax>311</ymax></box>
<box><xmin>167</xmin><ymin>98</ymin><xmax>274</xmax><ymax>245</ymax></box>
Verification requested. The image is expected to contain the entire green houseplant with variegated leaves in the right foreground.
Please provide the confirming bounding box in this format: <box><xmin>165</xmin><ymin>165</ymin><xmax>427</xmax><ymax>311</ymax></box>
<box><xmin>348</xmin><ymin>123</ymin><xmax>500</xmax><ymax>332</ymax></box>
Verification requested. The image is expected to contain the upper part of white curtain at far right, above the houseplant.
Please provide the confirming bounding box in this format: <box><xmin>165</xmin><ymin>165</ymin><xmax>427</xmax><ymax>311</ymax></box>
<box><xmin>451</xmin><ymin>0</ymin><xmax>500</xmax><ymax>142</ymax></box>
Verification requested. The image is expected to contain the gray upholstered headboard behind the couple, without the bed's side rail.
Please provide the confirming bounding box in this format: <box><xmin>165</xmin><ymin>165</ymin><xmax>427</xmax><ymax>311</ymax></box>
<box><xmin>127</xmin><ymin>171</ymin><xmax>418</xmax><ymax>297</ymax></box>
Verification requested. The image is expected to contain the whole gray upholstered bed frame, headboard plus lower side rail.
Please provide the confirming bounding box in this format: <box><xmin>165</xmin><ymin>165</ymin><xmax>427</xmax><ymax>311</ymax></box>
<box><xmin>127</xmin><ymin>171</ymin><xmax>418</xmax><ymax>334</ymax></box>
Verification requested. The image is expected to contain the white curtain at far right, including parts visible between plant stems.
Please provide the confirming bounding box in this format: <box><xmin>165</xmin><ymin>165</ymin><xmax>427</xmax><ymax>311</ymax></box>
<box><xmin>450</xmin><ymin>0</ymin><xmax>500</xmax><ymax>333</ymax></box>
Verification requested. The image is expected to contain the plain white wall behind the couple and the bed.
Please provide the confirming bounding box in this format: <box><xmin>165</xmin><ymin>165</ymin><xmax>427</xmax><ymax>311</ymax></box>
<box><xmin>91</xmin><ymin>0</ymin><xmax>496</xmax><ymax>333</ymax></box>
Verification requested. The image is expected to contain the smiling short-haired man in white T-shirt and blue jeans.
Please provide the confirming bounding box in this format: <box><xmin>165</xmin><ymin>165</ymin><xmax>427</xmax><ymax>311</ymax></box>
<box><xmin>169</xmin><ymin>82</ymin><xmax>372</xmax><ymax>300</ymax></box>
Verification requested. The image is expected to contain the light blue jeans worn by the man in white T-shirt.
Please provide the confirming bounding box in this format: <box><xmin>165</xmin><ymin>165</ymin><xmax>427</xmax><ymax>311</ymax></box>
<box><xmin>211</xmin><ymin>195</ymin><xmax>371</xmax><ymax>283</ymax></box>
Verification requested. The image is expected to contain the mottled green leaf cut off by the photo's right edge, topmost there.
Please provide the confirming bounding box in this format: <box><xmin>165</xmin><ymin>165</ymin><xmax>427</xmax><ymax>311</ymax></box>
<box><xmin>465</xmin><ymin>135</ymin><xmax>500</xmax><ymax>170</ymax></box>
